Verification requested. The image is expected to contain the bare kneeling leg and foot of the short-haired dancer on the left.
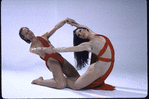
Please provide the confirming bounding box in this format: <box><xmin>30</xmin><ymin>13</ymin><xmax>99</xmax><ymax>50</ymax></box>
<box><xmin>32</xmin><ymin>58</ymin><xmax>66</xmax><ymax>89</ymax></box>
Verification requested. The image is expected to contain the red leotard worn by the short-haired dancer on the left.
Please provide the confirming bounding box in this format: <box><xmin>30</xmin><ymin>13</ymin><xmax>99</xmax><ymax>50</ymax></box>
<box><xmin>37</xmin><ymin>36</ymin><xmax>64</xmax><ymax>69</ymax></box>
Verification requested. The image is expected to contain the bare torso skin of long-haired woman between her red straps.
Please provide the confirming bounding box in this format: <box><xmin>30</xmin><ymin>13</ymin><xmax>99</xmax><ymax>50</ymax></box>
<box><xmin>91</xmin><ymin>35</ymin><xmax>113</xmax><ymax>76</ymax></box>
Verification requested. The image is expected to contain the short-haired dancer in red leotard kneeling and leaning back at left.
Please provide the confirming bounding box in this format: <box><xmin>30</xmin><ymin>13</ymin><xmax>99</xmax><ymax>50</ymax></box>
<box><xmin>19</xmin><ymin>18</ymin><xmax>80</xmax><ymax>89</ymax></box>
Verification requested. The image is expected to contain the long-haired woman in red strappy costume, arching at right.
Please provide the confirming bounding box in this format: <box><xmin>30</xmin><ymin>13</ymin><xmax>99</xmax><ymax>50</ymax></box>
<box><xmin>39</xmin><ymin>20</ymin><xmax>115</xmax><ymax>90</ymax></box>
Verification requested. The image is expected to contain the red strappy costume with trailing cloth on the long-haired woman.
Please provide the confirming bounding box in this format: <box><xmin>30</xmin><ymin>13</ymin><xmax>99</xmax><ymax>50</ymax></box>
<box><xmin>83</xmin><ymin>34</ymin><xmax>115</xmax><ymax>91</ymax></box>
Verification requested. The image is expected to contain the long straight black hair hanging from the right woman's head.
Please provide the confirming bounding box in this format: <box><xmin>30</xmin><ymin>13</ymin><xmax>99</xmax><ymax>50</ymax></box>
<box><xmin>73</xmin><ymin>27</ymin><xmax>89</xmax><ymax>69</ymax></box>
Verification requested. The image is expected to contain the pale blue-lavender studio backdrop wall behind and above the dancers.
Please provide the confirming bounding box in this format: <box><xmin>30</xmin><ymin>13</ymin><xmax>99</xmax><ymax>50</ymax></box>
<box><xmin>1</xmin><ymin>0</ymin><xmax>147</xmax><ymax>97</ymax></box>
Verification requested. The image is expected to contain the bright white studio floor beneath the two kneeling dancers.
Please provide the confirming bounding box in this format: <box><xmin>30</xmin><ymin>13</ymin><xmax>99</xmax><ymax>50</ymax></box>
<box><xmin>2</xmin><ymin>63</ymin><xmax>147</xmax><ymax>98</ymax></box>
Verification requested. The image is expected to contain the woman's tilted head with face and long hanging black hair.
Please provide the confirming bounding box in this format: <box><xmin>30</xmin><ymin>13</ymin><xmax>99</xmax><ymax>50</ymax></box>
<box><xmin>73</xmin><ymin>27</ymin><xmax>89</xmax><ymax>69</ymax></box>
